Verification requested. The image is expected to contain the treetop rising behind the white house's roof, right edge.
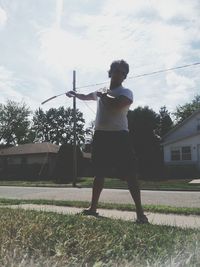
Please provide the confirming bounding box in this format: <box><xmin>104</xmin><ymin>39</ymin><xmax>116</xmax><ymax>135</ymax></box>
<box><xmin>173</xmin><ymin>95</ymin><xmax>200</xmax><ymax>124</ymax></box>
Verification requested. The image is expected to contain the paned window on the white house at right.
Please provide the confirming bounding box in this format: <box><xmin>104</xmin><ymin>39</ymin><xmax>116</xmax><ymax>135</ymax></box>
<box><xmin>171</xmin><ymin>146</ymin><xmax>192</xmax><ymax>161</ymax></box>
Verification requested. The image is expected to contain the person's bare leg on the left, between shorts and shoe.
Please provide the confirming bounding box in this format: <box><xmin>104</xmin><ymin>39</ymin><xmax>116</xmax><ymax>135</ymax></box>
<box><xmin>89</xmin><ymin>177</ymin><xmax>104</xmax><ymax>211</ymax></box>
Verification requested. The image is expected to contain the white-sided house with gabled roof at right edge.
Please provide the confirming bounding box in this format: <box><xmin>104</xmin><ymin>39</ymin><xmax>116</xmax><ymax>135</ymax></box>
<box><xmin>162</xmin><ymin>110</ymin><xmax>200</xmax><ymax>177</ymax></box>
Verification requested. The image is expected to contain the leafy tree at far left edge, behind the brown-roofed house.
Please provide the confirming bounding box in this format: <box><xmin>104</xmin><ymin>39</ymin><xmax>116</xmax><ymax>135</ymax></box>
<box><xmin>0</xmin><ymin>100</ymin><xmax>31</xmax><ymax>145</ymax></box>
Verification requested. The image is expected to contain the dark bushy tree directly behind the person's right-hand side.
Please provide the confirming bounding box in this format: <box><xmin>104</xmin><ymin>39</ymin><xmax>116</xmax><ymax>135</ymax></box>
<box><xmin>128</xmin><ymin>106</ymin><xmax>162</xmax><ymax>179</ymax></box>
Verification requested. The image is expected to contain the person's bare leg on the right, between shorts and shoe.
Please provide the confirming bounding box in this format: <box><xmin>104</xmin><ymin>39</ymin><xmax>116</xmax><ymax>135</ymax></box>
<box><xmin>126</xmin><ymin>177</ymin><xmax>144</xmax><ymax>219</ymax></box>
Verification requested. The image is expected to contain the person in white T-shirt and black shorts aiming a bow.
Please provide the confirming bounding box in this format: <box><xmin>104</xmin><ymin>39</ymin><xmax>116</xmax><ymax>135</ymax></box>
<box><xmin>66</xmin><ymin>59</ymin><xmax>148</xmax><ymax>223</ymax></box>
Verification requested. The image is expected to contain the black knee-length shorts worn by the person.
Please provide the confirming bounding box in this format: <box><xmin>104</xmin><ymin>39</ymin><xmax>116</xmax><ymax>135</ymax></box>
<box><xmin>92</xmin><ymin>131</ymin><xmax>136</xmax><ymax>179</ymax></box>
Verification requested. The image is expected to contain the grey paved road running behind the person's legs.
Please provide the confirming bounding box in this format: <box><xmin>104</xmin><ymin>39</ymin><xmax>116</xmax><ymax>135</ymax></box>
<box><xmin>0</xmin><ymin>186</ymin><xmax>200</xmax><ymax>208</ymax></box>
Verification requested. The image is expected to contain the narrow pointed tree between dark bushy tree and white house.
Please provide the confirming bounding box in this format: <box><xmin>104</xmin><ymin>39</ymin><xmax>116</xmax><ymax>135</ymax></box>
<box><xmin>156</xmin><ymin>106</ymin><xmax>173</xmax><ymax>138</ymax></box>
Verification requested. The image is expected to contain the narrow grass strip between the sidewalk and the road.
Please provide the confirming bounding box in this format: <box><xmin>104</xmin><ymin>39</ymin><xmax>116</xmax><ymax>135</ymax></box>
<box><xmin>0</xmin><ymin>198</ymin><xmax>200</xmax><ymax>215</ymax></box>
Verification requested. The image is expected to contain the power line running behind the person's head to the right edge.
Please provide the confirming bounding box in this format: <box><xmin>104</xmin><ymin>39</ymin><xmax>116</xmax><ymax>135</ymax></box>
<box><xmin>76</xmin><ymin>62</ymin><xmax>200</xmax><ymax>92</ymax></box>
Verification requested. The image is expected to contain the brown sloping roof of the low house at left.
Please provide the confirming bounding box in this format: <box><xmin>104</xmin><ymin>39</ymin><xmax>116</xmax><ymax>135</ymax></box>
<box><xmin>0</xmin><ymin>142</ymin><xmax>60</xmax><ymax>156</ymax></box>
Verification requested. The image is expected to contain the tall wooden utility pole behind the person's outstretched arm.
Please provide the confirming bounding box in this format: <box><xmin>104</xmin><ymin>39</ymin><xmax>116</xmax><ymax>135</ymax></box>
<box><xmin>73</xmin><ymin>70</ymin><xmax>77</xmax><ymax>187</ymax></box>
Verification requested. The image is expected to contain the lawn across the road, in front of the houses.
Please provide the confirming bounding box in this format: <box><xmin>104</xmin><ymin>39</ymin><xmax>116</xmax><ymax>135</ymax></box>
<box><xmin>0</xmin><ymin>177</ymin><xmax>200</xmax><ymax>191</ymax></box>
